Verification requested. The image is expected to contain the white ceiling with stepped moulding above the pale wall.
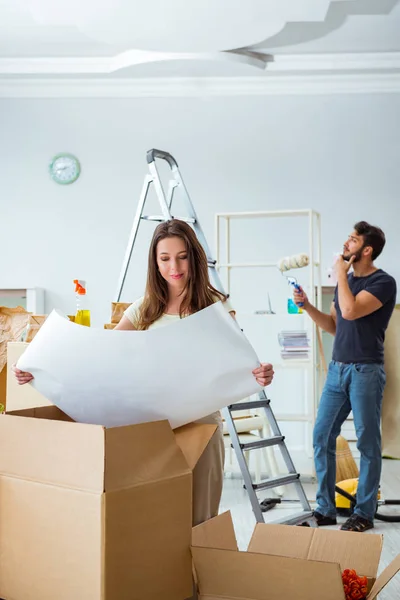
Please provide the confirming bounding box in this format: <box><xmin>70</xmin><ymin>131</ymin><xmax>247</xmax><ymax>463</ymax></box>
<box><xmin>0</xmin><ymin>0</ymin><xmax>400</xmax><ymax>86</ymax></box>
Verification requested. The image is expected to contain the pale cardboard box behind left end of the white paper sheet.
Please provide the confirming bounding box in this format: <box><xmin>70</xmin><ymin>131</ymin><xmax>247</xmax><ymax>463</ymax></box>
<box><xmin>6</xmin><ymin>342</ymin><xmax>51</xmax><ymax>412</ymax></box>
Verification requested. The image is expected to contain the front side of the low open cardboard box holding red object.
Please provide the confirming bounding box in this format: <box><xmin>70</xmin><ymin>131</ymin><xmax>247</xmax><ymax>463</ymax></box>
<box><xmin>192</xmin><ymin>548</ymin><xmax>345</xmax><ymax>600</ymax></box>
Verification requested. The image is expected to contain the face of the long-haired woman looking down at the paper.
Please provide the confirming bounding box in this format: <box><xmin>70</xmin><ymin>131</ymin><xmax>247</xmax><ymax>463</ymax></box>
<box><xmin>156</xmin><ymin>236</ymin><xmax>189</xmax><ymax>290</ymax></box>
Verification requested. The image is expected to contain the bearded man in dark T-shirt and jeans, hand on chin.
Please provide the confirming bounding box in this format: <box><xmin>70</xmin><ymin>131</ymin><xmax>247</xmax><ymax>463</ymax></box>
<box><xmin>294</xmin><ymin>221</ymin><xmax>396</xmax><ymax>532</ymax></box>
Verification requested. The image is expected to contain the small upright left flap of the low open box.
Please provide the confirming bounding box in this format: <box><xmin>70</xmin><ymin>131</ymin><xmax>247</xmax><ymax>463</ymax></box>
<box><xmin>192</xmin><ymin>511</ymin><xmax>237</xmax><ymax>550</ymax></box>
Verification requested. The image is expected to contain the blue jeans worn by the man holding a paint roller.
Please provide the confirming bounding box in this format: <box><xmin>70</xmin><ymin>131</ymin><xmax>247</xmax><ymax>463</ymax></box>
<box><xmin>313</xmin><ymin>361</ymin><xmax>386</xmax><ymax>521</ymax></box>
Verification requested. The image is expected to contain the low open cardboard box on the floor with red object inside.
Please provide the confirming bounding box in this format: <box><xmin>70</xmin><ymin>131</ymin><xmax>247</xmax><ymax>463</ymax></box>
<box><xmin>192</xmin><ymin>513</ymin><xmax>400</xmax><ymax>600</ymax></box>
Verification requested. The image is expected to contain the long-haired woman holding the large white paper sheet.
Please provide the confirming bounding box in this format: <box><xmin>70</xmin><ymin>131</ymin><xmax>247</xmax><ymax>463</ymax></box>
<box><xmin>14</xmin><ymin>219</ymin><xmax>274</xmax><ymax>525</ymax></box>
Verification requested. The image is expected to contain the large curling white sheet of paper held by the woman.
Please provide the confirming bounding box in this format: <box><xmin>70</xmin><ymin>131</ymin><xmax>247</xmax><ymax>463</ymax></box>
<box><xmin>17</xmin><ymin>302</ymin><xmax>261</xmax><ymax>428</ymax></box>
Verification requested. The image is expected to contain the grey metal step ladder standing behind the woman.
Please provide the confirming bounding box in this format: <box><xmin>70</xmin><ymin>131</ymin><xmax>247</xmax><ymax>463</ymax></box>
<box><xmin>115</xmin><ymin>149</ymin><xmax>314</xmax><ymax>526</ymax></box>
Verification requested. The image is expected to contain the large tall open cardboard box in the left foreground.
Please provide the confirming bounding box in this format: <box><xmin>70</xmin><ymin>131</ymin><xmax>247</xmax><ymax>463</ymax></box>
<box><xmin>0</xmin><ymin>406</ymin><xmax>215</xmax><ymax>600</ymax></box>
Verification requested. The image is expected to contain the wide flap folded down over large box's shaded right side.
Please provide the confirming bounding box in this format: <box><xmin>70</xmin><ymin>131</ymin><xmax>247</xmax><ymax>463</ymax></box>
<box><xmin>104</xmin><ymin>421</ymin><xmax>190</xmax><ymax>491</ymax></box>
